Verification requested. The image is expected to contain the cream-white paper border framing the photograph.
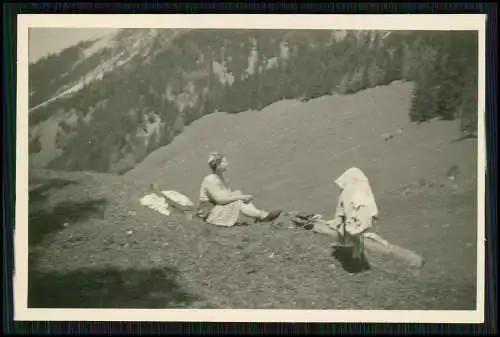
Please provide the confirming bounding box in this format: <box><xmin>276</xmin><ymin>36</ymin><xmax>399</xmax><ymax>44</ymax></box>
<box><xmin>13</xmin><ymin>14</ymin><xmax>486</xmax><ymax>323</ymax></box>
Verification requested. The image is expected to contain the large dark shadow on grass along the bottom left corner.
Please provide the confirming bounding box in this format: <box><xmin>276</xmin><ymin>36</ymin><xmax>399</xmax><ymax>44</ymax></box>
<box><xmin>28</xmin><ymin>267</ymin><xmax>197</xmax><ymax>309</ymax></box>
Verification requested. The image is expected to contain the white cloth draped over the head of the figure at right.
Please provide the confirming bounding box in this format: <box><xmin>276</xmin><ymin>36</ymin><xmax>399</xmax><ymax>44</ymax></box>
<box><xmin>335</xmin><ymin>167</ymin><xmax>378</xmax><ymax>217</ymax></box>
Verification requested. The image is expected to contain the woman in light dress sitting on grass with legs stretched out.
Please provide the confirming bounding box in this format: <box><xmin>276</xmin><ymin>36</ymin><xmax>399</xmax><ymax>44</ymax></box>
<box><xmin>197</xmin><ymin>153</ymin><xmax>281</xmax><ymax>227</ymax></box>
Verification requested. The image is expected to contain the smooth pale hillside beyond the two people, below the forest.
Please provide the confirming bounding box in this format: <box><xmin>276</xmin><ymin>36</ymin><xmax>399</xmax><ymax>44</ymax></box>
<box><xmin>125</xmin><ymin>82</ymin><xmax>477</xmax><ymax>214</ymax></box>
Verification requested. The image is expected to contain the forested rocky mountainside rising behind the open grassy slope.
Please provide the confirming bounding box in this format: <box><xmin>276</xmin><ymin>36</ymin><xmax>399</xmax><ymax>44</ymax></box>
<box><xmin>29</xmin><ymin>29</ymin><xmax>477</xmax><ymax>174</ymax></box>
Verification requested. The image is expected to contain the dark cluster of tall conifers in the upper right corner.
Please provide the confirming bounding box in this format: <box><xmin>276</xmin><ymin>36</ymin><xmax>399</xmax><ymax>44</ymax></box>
<box><xmin>410</xmin><ymin>31</ymin><xmax>478</xmax><ymax>134</ymax></box>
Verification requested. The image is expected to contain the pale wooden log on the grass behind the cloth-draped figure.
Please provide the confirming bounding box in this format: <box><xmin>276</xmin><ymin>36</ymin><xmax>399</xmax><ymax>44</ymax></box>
<box><xmin>312</xmin><ymin>222</ymin><xmax>424</xmax><ymax>268</ymax></box>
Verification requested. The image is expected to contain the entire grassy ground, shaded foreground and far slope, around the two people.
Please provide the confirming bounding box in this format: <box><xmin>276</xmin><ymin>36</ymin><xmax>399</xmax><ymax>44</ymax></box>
<box><xmin>29</xmin><ymin>83</ymin><xmax>477</xmax><ymax>309</ymax></box>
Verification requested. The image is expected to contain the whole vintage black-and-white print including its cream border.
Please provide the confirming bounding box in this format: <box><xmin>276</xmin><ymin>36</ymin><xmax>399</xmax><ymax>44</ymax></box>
<box><xmin>16</xmin><ymin>15</ymin><xmax>485</xmax><ymax>322</ymax></box>
